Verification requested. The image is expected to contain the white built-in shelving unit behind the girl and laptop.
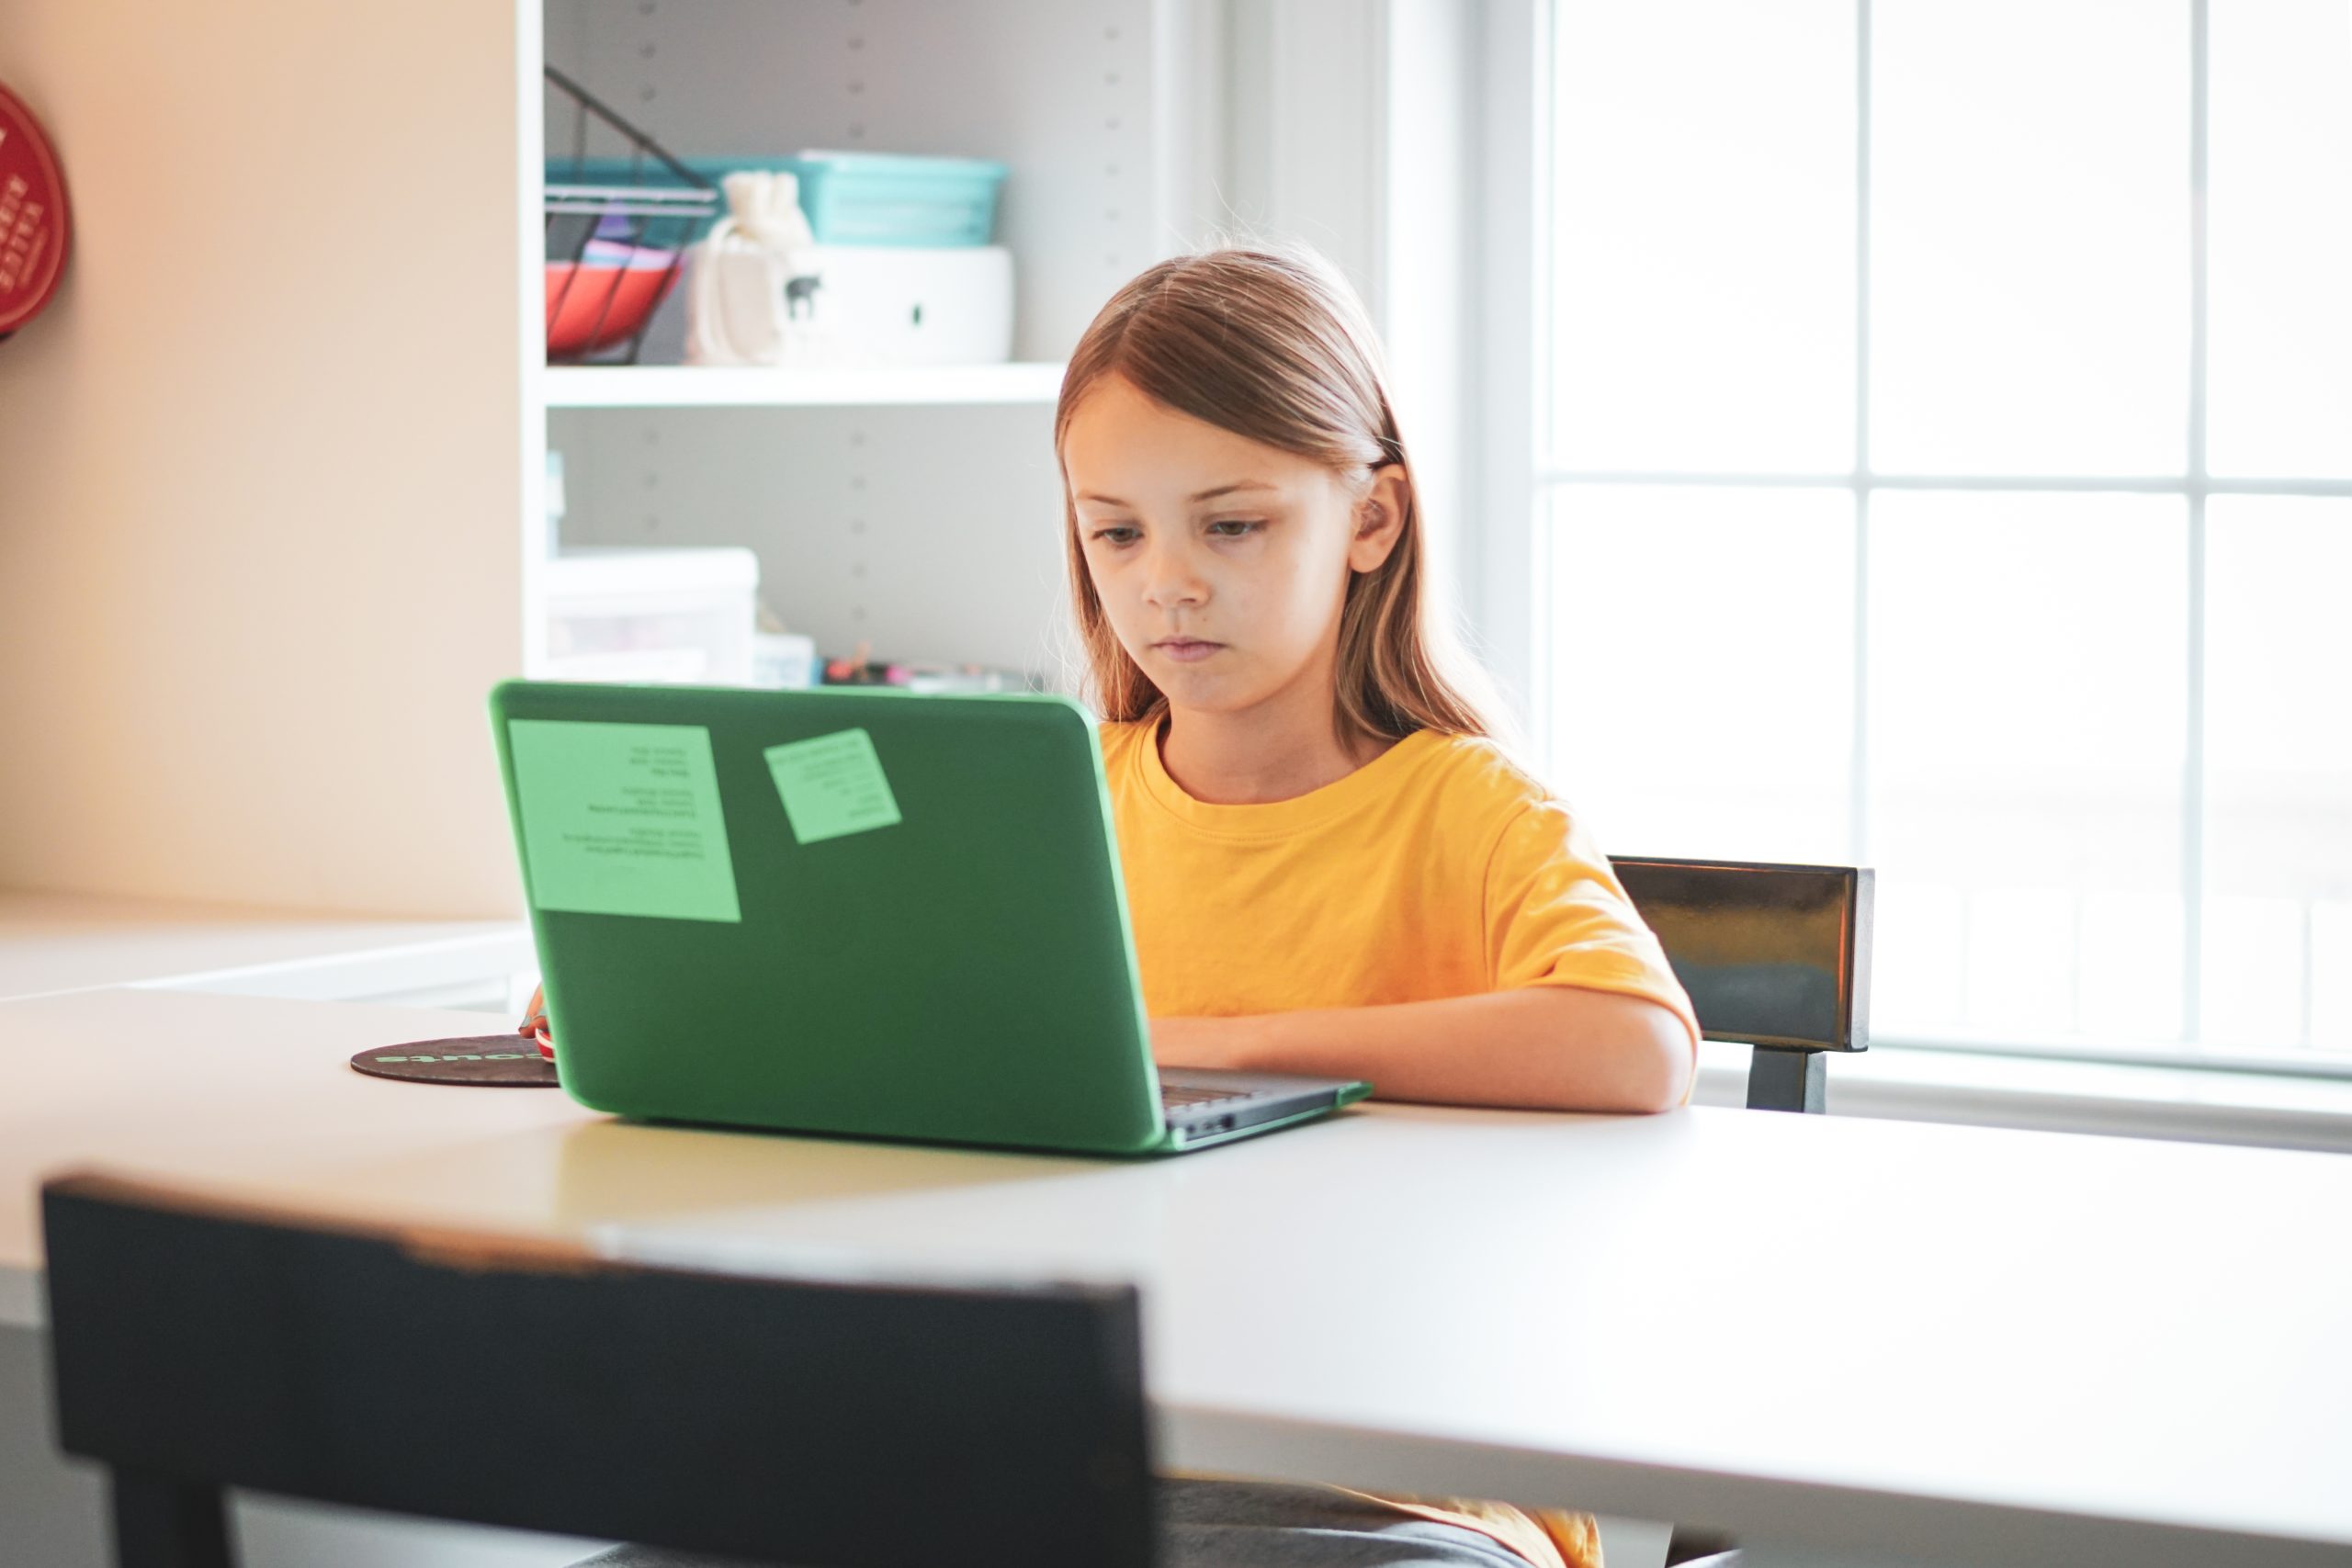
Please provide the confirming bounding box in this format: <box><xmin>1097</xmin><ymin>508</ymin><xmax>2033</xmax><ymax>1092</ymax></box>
<box><xmin>522</xmin><ymin>0</ymin><xmax>1221</xmax><ymax>680</ymax></box>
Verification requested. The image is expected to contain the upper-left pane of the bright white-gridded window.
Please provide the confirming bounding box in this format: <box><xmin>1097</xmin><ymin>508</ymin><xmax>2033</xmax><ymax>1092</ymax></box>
<box><xmin>1553</xmin><ymin>0</ymin><xmax>1853</xmax><ymax>472</ymax></box>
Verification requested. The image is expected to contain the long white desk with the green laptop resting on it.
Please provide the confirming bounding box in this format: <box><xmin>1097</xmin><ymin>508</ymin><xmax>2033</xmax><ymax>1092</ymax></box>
<box><xmin>0</xmin><ymin>989</ymin><xmax>2352</xmax><ymax>1568</ymax></box>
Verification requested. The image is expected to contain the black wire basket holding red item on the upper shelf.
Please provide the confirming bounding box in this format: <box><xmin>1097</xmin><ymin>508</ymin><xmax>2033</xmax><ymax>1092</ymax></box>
<box><xmin>546</xmin><ymin>66</ymin><xmax>719</xmax><ymax>365</ymax></box>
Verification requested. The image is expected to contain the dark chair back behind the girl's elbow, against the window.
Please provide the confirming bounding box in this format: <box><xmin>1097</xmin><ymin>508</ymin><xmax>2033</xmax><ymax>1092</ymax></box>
<box><xmin>1611</xmin><ymin>858</ymin><xmax>1874</xmax><ymax>1112</ymax></box>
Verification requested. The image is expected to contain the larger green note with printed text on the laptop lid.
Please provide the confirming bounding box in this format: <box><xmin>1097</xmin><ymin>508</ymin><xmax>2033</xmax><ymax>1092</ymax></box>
<box><xmin>505</xmin><ymin>719</ymin><xmax>743</xmax><ymax>921</ymax></box>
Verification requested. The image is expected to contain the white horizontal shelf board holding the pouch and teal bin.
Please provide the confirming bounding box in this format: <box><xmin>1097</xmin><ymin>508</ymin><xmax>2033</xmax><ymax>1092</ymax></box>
<box><xmin>546</xmin><ymin>365</ymin><xmax>1061</xmax><ymax>409</ymax></box>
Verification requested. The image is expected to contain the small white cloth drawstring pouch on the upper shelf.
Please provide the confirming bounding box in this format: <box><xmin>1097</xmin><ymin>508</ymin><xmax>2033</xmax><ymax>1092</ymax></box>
<box><xmin>687</xmin><ymin>169</ymin><xmax>831</xmax><ymax>365</ymax></box>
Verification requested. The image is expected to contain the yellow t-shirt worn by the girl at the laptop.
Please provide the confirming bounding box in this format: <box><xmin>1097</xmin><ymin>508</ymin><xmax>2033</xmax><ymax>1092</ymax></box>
<box><xmin>1103</xmin><ymin>724</ymin><xmax>1698</xmax><ymax>1568</ymax></box>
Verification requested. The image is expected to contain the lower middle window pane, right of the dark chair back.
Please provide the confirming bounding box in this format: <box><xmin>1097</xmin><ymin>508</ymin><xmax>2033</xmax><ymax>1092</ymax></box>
<box><xmin>1868</xmin><ymin>491</ymin><xmax>2188</xmax><ymax>1039</ymax></box>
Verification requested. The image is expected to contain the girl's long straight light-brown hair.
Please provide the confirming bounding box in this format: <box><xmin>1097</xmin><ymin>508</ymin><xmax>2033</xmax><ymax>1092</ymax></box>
<box><xmin>1054</xmin><ymin>247</ymin><xmax>1498</xmax><ymax>740</ymax></box>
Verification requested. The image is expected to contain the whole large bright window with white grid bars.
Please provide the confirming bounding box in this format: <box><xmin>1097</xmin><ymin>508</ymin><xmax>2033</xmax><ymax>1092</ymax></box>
<box><xmin>1532</xmin><ymin>0</ymin><xmax>2352</xmax><ymax>1072</ymax></box>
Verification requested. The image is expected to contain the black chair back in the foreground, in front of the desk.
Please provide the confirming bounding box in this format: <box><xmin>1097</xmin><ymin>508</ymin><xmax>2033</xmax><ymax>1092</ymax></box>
<box><xmin>42</xmin><ymin>1176</ymin><xmax>1155</xmax><ymax>1568</ymax></box>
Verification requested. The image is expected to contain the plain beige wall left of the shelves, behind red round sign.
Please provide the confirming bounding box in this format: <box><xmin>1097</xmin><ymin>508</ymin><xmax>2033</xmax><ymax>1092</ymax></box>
<box><xmin>0</xmin><ymin>0</ymin><xmax>541</xmax><ymax>917</ymax></box>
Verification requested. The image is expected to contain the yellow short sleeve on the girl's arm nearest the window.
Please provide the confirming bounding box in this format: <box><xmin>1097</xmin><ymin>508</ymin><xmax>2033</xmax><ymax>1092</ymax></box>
<box><xmin>1484</xmin><ymin>799</ymin><xmax>1698</xmax><ymax>1051</ymax></box>
